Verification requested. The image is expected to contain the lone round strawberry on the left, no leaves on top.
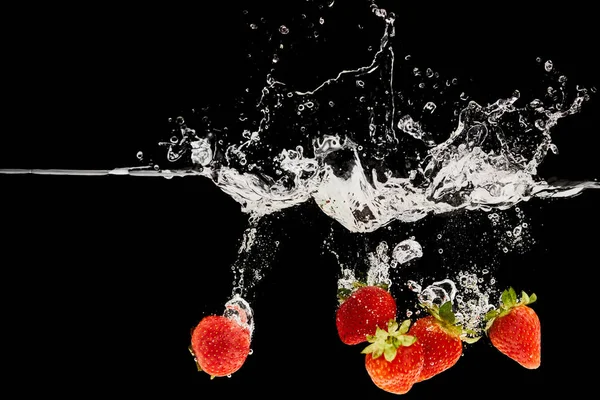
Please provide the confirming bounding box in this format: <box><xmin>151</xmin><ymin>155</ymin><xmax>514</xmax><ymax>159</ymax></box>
<box><xmin>190</xmin><ymin>315</ymin><xmax>250</xmax><ymax>378</ymax></box>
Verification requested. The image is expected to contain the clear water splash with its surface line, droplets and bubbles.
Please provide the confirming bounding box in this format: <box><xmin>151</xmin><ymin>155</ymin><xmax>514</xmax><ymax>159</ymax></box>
<box><xmin>0</xmin><ymin>1</ymin><xmax>600</xmax><ymax>372</ymax></box>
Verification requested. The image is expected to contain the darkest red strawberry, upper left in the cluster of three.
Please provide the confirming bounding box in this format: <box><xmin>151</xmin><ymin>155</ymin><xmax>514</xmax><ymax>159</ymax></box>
<box><xmin>335</xmin><ymin>286</ymin><xmax>396</xmax><ymax>345</ymax></box>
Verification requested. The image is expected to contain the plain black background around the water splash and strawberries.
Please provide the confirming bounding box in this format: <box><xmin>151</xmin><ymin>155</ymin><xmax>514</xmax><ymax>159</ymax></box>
<box><xmin>0</xmin><ymin>0</ymin><xmax>600</xmax><ymax>398</ymax></box>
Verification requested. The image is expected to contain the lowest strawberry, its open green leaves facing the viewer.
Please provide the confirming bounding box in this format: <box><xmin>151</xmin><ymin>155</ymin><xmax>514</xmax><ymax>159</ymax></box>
<box><xmin>362</xmin><ymin>320</ymin><xmax>423</xmax><ymax>394</ymax></box>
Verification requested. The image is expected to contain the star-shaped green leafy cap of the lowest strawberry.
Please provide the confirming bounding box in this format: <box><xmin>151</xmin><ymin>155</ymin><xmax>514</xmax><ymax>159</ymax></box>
<box><xmin>361</xmin><ymin>319</ymin><xmax>417</xmax><ymax>362</ymax></box>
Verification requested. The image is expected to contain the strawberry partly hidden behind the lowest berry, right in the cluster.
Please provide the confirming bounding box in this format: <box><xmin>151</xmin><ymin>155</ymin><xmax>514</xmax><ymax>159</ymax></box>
<box><xmin>410</xmin><ymin>301</ymin><xmax>479</xmax><ymax>382</ymax></box>
